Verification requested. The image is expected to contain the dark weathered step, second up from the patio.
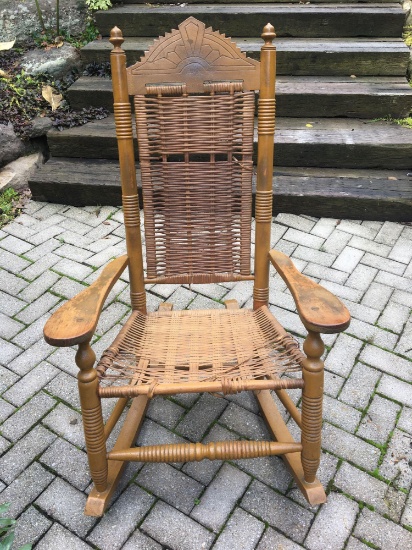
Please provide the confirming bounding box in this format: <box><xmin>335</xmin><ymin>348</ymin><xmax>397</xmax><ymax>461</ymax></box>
<box><xmin>48</xmin><ymin>115</ymin><xmax>412</xmax><ymax>170</ymax></box>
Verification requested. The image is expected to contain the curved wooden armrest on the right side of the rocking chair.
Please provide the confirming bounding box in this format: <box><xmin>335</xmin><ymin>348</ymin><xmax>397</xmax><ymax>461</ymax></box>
<box><xmin>269</xmin><ymin>250</ymin><xmax>350</xmax><ymax>333</ymax></box>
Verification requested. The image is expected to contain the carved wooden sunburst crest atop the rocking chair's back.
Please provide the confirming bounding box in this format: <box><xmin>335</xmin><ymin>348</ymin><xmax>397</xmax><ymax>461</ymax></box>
<box><xmin>127</xmin><ymin>17</ymin><xmax>260</xmax><ymax>94</ymax></box>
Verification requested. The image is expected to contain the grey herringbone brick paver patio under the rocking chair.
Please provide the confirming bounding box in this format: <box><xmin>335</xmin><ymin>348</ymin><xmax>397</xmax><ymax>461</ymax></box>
<box><xmin>0</xmin><ymin>202</ymin><xmax>412</xmax><ymax>550</ymax></box>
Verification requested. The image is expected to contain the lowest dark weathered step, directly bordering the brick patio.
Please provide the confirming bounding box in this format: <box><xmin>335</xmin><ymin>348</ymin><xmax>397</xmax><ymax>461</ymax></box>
<box><xmin>30</xmin><ymin>158</ymin><xmax>412</xmax><ymax>221</ymax></box>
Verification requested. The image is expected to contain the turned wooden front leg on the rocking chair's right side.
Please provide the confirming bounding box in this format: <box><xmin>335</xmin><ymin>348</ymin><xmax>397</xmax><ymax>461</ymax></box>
<box><xmin>302</xmin><ymin>331</ymin><xmax>325</xmax><ymax>483</ymax></box>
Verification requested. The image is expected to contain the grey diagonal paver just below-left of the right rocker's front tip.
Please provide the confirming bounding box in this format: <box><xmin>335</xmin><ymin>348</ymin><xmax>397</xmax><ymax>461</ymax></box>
<box><xmin>241</xmin><ymin>481</ymin><xmax>313</xmax><ymax>542</ymax></box>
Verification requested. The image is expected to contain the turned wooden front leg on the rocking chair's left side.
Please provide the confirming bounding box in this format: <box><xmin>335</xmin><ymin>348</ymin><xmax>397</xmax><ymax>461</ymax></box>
<box><xmin>76</xmin><ymin>342</ymin><xmax>107</xmax><ymax>493</ymax></box>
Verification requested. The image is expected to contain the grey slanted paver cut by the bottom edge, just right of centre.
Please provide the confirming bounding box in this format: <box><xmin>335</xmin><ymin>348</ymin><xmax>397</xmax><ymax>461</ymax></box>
<box><xmin>213</xmin><ymin>508</ymin><xmax>265</xmax><ymax>550</ymax></box>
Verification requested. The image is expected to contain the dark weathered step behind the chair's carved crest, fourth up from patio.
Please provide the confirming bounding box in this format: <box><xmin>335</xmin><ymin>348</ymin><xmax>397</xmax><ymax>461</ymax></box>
<box><xmin>81</xmin><ymin>34</ymin><xmax>410</xmax><ymax>76</ymax></box>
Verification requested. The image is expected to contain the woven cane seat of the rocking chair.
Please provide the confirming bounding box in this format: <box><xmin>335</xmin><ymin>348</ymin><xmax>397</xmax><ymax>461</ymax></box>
<box><xmin>97</xmin><ymin>306</ymin><xmax>304</xmax><ymax>385</ymax></box>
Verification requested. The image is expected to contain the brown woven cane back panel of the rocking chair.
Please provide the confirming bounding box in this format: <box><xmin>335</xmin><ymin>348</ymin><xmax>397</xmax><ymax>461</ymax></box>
<box><xmin>135</xmin><ymin>85</ymin><xmax>255</xmax><ymax>283</ymax></box>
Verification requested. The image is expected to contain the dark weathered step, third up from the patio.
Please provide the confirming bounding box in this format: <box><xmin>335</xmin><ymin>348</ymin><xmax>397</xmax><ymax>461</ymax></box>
<box><xmin>68</xmin><ymin>76</ymin><xmax>412</xmax><ymax>119</ymax></box>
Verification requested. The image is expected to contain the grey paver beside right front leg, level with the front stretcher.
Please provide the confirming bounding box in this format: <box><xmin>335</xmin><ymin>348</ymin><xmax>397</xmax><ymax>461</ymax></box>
<box><xmin>322</xmin><ymin>423</ymin><xmax>380</xmax><ymax>471</ymax></box>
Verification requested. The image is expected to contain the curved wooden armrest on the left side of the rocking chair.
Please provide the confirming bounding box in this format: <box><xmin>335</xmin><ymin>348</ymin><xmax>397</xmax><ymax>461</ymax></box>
<box><xmin>43</xmin><ymin>255</ymin><xmax>129</xmax><ymax>347</ymax></box>
